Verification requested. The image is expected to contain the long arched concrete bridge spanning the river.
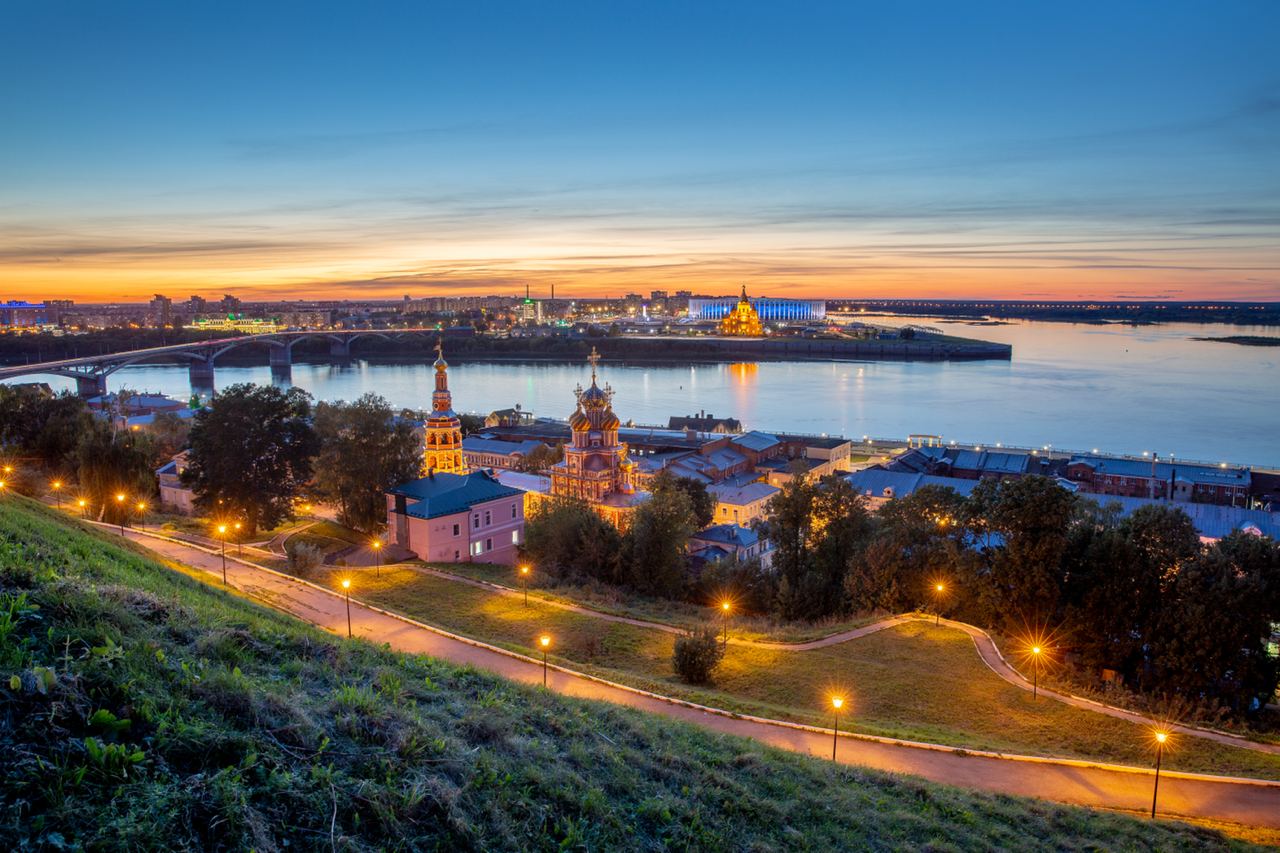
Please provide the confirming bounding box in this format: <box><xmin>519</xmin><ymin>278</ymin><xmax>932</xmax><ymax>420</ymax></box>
<box><xmin>0</xmin><ymin>328</ymin><xmax>440</xmax><ymax>397</ymax></box>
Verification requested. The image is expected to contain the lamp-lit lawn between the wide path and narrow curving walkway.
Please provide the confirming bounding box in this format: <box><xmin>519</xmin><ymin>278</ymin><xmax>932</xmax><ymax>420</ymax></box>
<box><xmin>312</xmin><ymin>567</ymin><xmax>1280</xmax><ymax>779</ymax></box>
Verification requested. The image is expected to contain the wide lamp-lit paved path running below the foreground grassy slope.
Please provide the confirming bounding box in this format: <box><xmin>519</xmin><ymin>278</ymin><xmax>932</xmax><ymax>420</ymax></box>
<box><xmin>112</xmin><ymin>526</ymin><xmax>1280</xmax><ymax>829</ymax></box>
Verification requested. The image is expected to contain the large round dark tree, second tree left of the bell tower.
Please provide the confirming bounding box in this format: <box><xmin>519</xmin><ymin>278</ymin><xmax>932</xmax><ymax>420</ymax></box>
<box><xmin>183</xmin><ymin>383</ymin><xmax>317</xmax><ymax>534</ymax></box>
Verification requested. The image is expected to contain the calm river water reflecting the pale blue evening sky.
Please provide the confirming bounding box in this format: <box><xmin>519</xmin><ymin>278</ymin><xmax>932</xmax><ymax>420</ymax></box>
<box><xmin>22</xmin><ymin>318</ymin><xmax>1280</xmax><ymax>466</ymax></box>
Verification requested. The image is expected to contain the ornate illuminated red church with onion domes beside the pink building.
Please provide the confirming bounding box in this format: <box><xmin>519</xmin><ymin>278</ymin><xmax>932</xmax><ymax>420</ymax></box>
<box><xmin>550</xmin><ymin>347</ymin><xmax>648</xmax><ymax>526</ymax></box>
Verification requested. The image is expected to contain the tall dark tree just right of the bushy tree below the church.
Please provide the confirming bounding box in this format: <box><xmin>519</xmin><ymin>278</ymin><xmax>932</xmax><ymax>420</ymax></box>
<box><xmin>618</xmin><ymin>485</ymin><xmax>698</xmax><ymax>598</ymax></box>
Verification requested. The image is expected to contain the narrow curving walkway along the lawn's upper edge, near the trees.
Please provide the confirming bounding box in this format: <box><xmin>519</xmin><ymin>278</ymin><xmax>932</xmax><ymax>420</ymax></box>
<box><xmin>401</xmin><ymin>564</ymin><xmax>1280</xmax><ymax>756</ymax></box>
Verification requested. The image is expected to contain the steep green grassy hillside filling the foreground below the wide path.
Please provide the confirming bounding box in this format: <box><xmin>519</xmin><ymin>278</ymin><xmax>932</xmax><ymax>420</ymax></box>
<box><xmin>0</xmin><ymin>497</ymin><xmax>1259</xmax><ymax>850</ymax></box>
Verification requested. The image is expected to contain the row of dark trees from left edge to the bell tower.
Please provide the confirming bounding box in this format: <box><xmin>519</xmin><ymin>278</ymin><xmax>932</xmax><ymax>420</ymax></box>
<box><xmin>0</xmin><ymin>383</ymin><xmax>421</xmax><ymax>534</ymax></box>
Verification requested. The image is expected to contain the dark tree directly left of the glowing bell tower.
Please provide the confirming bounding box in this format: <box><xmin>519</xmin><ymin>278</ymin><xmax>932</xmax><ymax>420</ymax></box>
<box><xmin>315</xmin><ymin>393</ymin><xmax>422</xmax><ymax>533</ymax></box>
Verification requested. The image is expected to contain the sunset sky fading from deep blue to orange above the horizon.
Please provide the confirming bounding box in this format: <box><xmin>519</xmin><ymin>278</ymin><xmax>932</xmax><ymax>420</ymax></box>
<box><xmin>0</xmin><ymin>0</ymin><xmax>1280</xmax><ymax>301</ymax></box>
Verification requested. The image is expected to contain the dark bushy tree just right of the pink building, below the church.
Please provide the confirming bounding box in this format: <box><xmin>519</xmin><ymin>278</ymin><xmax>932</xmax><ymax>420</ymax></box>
<box><xmin>521</xmin><ymin>497</ymin><xmax>622</xmax><ymax>583</ymax></box>
